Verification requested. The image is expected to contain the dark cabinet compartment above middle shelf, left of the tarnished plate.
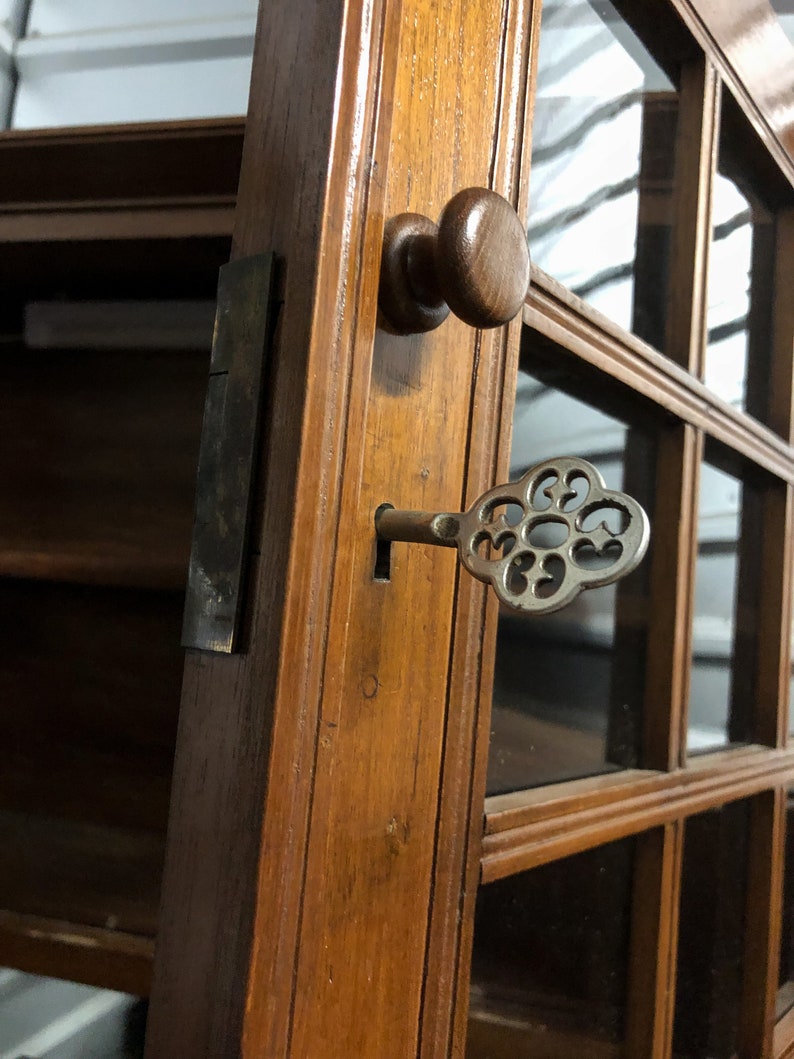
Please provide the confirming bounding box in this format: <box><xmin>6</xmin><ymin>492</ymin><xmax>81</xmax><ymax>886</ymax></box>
<box><xmin>0</xmin><ymin>348</ymin><xmax>209</xmax><ymax>591</ymax></box>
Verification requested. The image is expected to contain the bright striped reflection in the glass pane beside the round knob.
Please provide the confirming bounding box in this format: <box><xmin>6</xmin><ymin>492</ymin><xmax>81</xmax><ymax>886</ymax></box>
<box><xmin>528</xmin><ymin>2</ymin><xmax>645</xmax><ymax>326</ymax></box>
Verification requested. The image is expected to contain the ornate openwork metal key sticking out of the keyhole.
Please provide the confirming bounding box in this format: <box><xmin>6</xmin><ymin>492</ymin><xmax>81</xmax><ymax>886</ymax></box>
<box><xmin>375</xmin><ymin>456</ymin><xmax>650</xmax><ymax>614</ymax></box>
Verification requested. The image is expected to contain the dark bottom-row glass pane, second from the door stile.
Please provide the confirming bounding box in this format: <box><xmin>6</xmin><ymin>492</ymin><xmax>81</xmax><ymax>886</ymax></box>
<box><xmin>672</xmin><ymin>802</ymin><xmax>748</xmax><ymax>1059</ymax></box>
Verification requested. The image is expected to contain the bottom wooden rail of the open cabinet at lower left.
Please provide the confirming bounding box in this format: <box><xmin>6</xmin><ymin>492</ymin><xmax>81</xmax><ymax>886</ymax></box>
<box><xmin>0</xmin><ymin>910</ymin><xmax>155</xmax><ymax>997</ymax></box>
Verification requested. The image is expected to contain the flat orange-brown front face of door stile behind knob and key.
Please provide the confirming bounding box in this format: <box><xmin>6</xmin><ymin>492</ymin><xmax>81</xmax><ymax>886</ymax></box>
<box><xmin>281</xmin><ymin>3</ymin><xmax>535</xmax><ymax>1057</ymax></box>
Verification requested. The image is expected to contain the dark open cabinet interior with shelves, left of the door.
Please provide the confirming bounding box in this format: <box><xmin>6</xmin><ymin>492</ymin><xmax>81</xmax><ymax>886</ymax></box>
<box><xmin>0</xmin><ymin>122</ymin><xmax>242</xmax><ymax>993</ymax></box>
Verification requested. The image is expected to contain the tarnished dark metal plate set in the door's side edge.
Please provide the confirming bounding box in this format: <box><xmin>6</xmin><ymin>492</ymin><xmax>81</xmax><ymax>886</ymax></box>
<box><xmin>182</xmin><ymin>254</ymin><xmax>273</xmax><ymax>653</ymax></box>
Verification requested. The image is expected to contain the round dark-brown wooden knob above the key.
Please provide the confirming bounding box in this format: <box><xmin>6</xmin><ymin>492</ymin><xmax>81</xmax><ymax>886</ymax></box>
<box><xmin>378</xmin><ymin>187</ymin><xmax>529</xmax><ymax>335</ymax></box>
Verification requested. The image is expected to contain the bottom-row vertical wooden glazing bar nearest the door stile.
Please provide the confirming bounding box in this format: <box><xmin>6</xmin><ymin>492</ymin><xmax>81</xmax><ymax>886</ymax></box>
<box><xmin>625</xmin><ymin>821</ymin><xmax>684</xmax><ymax>1059</ymax></box>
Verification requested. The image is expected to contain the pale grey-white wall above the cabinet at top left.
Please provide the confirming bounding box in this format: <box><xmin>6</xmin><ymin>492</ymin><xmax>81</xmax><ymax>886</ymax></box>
<box><xmin>0</xmin><ymin>0</ymin><xmax>257</xmax><ymax>128</ymax></box>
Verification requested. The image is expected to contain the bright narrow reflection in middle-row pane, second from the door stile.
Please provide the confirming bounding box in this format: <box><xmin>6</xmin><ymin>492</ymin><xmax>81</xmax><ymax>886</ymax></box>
<box><xmin>687</xmin><ymin>463</ymin><xmax>758</xmax><ymax>753</ymax></box>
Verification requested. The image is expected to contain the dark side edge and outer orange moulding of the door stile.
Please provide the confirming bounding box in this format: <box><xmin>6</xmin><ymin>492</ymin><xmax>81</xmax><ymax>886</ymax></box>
<box><xmin>147</xmin><ymin>0</ymin><xmax>399</xmax><ymax>1057</ymax></box>
